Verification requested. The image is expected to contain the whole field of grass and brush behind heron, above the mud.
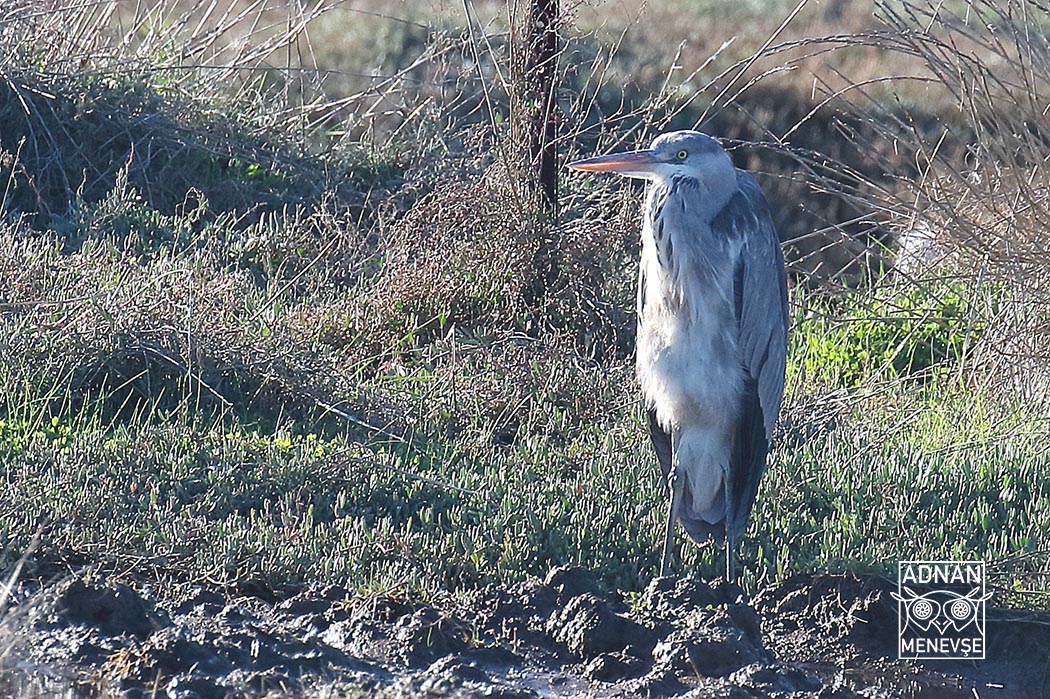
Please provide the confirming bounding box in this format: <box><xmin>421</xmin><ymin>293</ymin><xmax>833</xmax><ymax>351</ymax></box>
<box><xmin>0</xmin><ymin>0</ymin><xmax>1050</xmax><ymax>607</ymax></box>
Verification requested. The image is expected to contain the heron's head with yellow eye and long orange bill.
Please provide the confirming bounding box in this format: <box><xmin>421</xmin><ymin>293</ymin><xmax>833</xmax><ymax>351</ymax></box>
<box><xmin>568</xmin><ymin>131</ymin><xmax>734</xmax><ymax>182</ymax></box>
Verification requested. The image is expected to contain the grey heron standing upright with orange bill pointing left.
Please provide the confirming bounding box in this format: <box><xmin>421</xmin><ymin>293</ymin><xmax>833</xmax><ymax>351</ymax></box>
<box><xmin>569</xmin><ymin>131</ymin><xmax>789</xmax><ymax>580</ymax></box>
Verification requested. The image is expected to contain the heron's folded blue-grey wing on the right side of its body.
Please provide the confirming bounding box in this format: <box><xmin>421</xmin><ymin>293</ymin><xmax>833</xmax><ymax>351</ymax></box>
<box><xmin>712</xmin><ymin>171</ymin><xmax>788</xmax><ymax>541</ymax></box>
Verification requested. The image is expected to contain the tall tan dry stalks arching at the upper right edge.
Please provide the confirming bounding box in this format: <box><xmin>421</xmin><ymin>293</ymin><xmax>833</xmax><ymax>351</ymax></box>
<box><xmin>806</xmin><ymin>0</ymin><xmax>1050</xmax><ymax>398</ymax></box>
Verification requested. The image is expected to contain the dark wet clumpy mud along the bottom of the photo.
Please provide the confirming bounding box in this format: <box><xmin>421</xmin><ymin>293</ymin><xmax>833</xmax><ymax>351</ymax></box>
<box><xmin>0</xmin><ymin>568</ymin><xmax>1050</xmax><ymax>699</ymax></box>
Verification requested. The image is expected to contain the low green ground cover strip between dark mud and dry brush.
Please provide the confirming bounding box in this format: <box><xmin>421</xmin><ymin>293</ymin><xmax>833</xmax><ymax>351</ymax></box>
<box><xmin>2</xmin><ymin>342</ymin><xmax>1050</xmax><ymax>591</ymax></box>
